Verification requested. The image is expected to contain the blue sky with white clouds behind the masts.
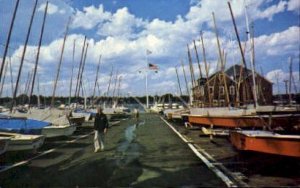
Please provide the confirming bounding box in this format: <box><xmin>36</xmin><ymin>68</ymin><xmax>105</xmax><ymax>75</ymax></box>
<box><xmin>0</xmin><ymin>0</ymin><xmax>300</xmax><ymax>96</ymax></box>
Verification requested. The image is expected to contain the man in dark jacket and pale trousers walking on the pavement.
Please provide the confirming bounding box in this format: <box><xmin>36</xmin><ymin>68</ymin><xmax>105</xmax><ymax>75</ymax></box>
<box><xmin>94</xmin><ymin>107</ymin><xmax>108</xmax><ymax>152</ymax></box>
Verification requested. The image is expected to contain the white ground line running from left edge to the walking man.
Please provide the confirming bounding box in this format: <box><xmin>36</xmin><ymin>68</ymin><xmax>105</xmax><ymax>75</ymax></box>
<box><xmin>0</xmin><ymin>131</ymin><xmax>94</xmax><ymax>173</ymax></box>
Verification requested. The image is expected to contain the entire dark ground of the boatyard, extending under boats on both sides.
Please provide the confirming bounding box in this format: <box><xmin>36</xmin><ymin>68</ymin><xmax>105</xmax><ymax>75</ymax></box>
<box><xmin>0</xmin><ymin>114</ymin><xmax>300</xmax><ymax>187</ymax></box>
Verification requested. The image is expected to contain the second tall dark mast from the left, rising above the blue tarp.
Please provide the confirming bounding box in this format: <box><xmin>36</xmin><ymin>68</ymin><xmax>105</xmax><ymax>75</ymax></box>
<box><xmin>10</xmin><ymin>0</ymin><xmax>38</xmax><ymax>112</ymax></box>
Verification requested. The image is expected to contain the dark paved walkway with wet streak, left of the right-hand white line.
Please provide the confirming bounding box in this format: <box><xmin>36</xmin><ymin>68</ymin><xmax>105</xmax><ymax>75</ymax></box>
<box><xmin>0</xmin><ymin>114</ymin><xmax>225</xmax><ymax>187</ymax></box>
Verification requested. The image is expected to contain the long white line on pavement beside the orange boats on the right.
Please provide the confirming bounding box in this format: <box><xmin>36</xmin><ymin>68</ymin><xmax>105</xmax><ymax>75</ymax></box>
<box><xmin>160</xmin><ymin>117</ymin><xmax>237</xmax><ymax>187</ymax></box>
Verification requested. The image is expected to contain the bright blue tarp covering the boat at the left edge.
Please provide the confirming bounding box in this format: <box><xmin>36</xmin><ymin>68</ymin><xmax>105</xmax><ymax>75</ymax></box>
<box><xmin>0</xmin><ymin>117</ymin><xmax>50</xmax><ymax>134</ymax></box>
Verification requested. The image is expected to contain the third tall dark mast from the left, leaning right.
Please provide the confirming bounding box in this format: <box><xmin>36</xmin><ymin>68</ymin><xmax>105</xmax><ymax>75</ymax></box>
<box><xmin>29</xmin><ymin>1</ymin><xmax>48</xmax><ymax>107</ymax></box>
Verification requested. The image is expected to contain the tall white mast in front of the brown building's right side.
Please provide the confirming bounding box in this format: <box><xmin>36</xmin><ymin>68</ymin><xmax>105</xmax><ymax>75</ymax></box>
<box><xmin>244</xmin><ymin>1</ymin><xmax>258</xmax><ymax>107</ymax></box>
